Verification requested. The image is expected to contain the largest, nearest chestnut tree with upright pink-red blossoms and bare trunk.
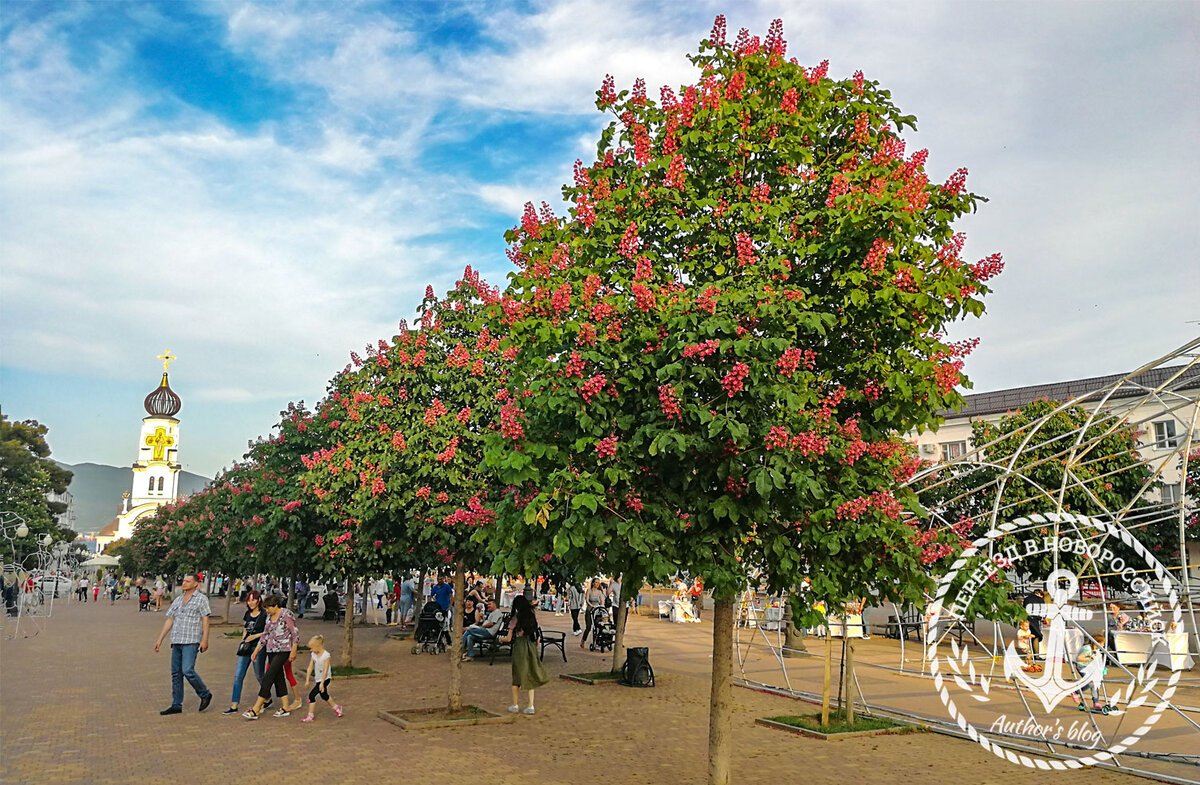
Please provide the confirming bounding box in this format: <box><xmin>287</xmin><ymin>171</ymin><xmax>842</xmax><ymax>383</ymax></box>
<box><xmin>492</xmin><ymin>17</ymin><xmax>1001</xmax><ymax>783</ymax></box>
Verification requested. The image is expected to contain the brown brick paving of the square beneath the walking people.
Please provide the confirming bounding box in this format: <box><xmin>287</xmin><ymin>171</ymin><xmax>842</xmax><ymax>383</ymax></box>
<box><xmin>0</xmin><ymin>599</ymin><xmax>1161</xmax><ymax>785</ymax></box>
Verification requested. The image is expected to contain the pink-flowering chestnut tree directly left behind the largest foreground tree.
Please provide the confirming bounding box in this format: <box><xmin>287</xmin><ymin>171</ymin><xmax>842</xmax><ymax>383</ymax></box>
<box><xmin>305</xmin><ymin>266</ymin><xmax>515</xmax><ymax>712</ymax></box>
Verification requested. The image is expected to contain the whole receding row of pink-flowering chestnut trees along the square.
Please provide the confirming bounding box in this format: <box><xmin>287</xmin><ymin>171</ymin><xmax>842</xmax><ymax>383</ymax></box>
<box><xmin>117</xmin><ymin>17</ymin><xmax>1022</xmax><ymax>783</ymax></box>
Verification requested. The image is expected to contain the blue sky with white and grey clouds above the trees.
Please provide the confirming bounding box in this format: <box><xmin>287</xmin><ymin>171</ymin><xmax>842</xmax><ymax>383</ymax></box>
<box><xmin>0</xmin><ymin>0</ymin><xmax>1200</xmax><ymax>475</ymax></box>
